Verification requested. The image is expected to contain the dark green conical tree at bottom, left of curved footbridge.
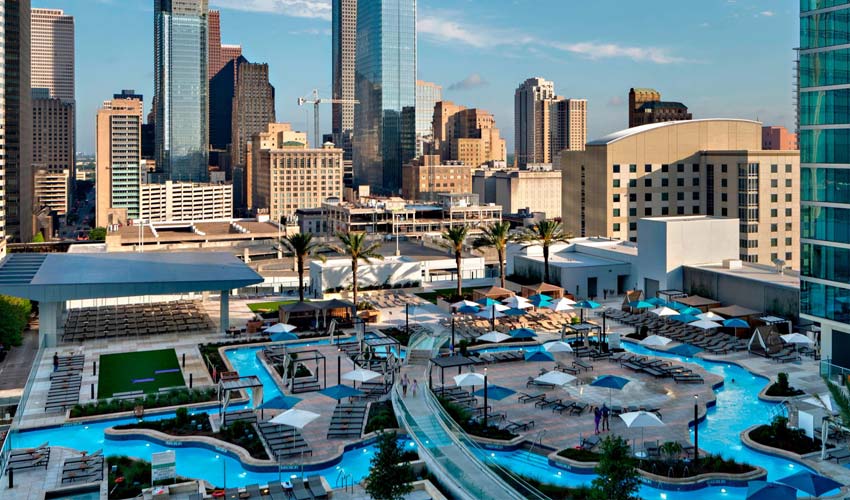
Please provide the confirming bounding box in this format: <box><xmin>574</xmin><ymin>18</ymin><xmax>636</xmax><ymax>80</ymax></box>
<box><xmin>366</xmin><ymin>432</ymin><xmax>415</xmax><ymax>500</ymax></box>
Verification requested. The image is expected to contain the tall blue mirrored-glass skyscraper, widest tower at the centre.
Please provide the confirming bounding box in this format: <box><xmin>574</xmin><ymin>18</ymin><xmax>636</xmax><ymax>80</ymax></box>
<box><xmin>354</xmin><ymin>0</ymin><xmax>416</xmax><ymax>193</ymax></box>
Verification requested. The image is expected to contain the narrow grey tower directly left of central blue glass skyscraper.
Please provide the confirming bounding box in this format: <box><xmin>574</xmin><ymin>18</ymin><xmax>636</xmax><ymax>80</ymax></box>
<box><xmin>331</xmin><ymin>0</ymin><xmax>357</xmax><ymax>160</ymax></box>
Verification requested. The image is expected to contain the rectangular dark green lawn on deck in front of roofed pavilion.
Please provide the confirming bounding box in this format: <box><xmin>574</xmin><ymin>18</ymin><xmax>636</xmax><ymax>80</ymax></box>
<box><xmin>97</xmin><ymin>349</ymin><xmax>186</xmax><ymax>399</ymax></box>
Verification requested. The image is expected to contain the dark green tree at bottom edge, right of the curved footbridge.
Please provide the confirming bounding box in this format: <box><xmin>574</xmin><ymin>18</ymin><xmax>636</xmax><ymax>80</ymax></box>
<box><xmin>591</xmin><ymin>436</ymin><xmax>640</xmax><ymax>500</ymax></box>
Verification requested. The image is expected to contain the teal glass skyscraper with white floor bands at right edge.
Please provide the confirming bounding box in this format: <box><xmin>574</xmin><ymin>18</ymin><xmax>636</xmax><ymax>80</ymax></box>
<box><xmin>798</xmin><ymin>0</ymin><xmax>850</xmax><ymax>367</ymax></box>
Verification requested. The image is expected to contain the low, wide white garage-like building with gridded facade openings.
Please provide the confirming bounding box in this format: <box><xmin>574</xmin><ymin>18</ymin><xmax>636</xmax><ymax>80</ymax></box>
<box><xmin>140</xmin><ymin>181</ymin><xmax>233</xmax><ymax>223</ymax></box>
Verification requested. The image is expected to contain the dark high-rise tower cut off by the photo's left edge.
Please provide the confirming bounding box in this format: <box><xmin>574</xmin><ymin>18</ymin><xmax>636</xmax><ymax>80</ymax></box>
<box><xmin>0</xmin><ymin>0</ymin><xmax>34</xmax><ymax>242</ymax></box>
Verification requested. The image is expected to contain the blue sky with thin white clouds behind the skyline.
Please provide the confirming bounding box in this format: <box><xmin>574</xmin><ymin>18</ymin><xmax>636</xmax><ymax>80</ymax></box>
<box><xmin>32</xmin><ymin>0</ymin><xmax>799</xmax><ymax>152</ymax></box>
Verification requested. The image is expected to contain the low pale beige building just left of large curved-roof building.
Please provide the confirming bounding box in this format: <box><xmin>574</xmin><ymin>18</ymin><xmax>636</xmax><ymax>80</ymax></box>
<box><xmin>472</xmin><ymin>165</ymin><xmax>562</xmax><ymax>219</ymax></box>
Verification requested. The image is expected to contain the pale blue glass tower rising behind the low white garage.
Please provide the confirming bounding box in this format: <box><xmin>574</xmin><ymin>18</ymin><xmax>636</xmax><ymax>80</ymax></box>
<box><xmin>154</xmin><ymin>0</ymin><xmax>209</xmax><ymax>182</ymax></box>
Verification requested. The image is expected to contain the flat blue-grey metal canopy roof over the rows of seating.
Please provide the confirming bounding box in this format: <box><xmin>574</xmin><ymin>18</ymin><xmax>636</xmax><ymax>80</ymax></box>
<box><xmin>0</xmin><ymin>252</ymin><xmax>263</xmax><ymax>302</ymax></box>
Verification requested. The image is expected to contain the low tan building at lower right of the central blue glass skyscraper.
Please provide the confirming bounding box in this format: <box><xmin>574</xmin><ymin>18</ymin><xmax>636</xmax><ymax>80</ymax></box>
<box><xmin>401</xmin><ymin>155</ymin><xmax>472</xmax><ymax>201</ymax></box>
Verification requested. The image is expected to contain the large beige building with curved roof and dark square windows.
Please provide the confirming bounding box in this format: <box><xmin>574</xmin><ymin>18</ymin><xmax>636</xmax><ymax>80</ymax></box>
<box><xmin>561</xmin><ymin>119</ymin><xmax>800</xmax><ymax>268</ymax></box>
